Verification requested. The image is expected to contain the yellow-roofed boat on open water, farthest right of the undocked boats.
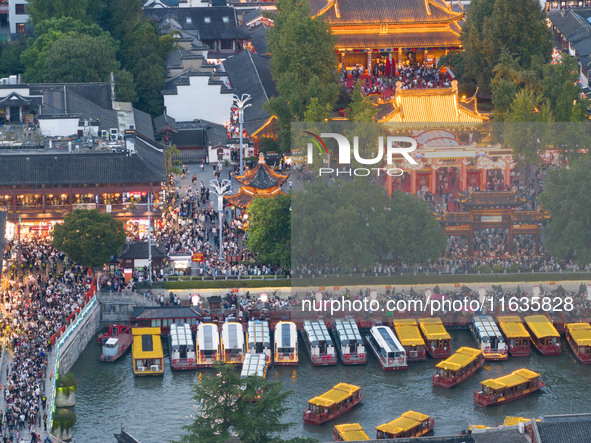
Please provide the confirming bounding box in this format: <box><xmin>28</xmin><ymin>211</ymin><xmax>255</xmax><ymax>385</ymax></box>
<box><xmin>474</xmin><ymin>369</ymin><xmax>546</xmax><ymax>406</ymax></box>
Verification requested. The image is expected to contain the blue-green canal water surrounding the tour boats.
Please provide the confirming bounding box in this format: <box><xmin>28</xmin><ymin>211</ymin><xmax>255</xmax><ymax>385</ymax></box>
<box><xmin>72</xmin><ymin>331</ymin><xmax>591</xmax><ymax>443</ymax></box>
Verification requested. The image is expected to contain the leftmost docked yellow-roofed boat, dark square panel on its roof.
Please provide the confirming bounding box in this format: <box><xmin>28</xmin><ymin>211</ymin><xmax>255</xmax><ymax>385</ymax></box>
<box><xmin>131</xmin><ymin>328</ymin><xmax>164</xmax><ymax>376</ymax></box>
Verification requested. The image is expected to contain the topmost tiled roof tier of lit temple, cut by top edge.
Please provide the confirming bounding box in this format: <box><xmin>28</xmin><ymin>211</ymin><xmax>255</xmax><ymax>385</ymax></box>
<box><xmin>309</xmin><ymin>0</ymin><xmax>464</xmax><ymax>26</ymax></box>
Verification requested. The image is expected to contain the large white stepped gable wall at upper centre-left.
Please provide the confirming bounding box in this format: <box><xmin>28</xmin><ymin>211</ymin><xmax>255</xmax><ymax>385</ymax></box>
<box><xmin>164</xmin><ymin>76</ymin><xmax>232</xmax><ymax>125</ymax></box>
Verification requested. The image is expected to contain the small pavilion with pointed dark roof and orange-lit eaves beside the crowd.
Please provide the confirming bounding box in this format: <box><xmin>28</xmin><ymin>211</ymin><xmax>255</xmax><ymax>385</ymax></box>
<box><xmin>224</xmin><ymin>154</ymin><xmax>289</xmax><ymax>209</ymax></box>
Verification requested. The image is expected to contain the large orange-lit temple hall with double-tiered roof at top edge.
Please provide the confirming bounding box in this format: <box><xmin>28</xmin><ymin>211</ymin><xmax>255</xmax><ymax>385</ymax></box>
<box><xmin>309</xmin><ymin>0</ymin><xmax>464</xmax><ymax>70</ymax></box>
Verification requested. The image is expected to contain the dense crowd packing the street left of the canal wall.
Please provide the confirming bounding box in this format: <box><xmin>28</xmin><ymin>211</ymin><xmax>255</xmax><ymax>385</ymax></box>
<box><xmin>0</xmin><ymin>238</ymin><xmax>91</xmax><ymax>442</ymax></box>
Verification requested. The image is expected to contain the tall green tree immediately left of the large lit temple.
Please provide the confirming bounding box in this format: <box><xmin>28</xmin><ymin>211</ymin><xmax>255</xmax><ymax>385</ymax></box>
<box><xmin>266</xmin><ymin>0</ymin><xmax>340</xmax><ymax>151</ymax></box>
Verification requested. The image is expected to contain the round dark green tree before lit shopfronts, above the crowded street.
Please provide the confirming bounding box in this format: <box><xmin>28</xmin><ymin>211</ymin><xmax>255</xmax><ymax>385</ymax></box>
<box><xmin>52</xmin><ymin>209</ymin><xmax>127</xmax><ymax>267</ymax></box>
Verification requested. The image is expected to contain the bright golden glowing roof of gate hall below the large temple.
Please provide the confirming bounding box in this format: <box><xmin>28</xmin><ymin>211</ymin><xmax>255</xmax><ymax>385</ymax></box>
<box><xmin>381</xmin><ymin>80</ymin><xmax>489</xmax><ymax>128</ymax></box>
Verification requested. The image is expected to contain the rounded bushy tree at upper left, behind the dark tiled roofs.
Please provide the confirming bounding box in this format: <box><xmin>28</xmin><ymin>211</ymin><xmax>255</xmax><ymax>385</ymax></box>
<box><xmin>44</xmin><ymin>34</ymin><xmax>119</xmax><ymax>83</ymax></box>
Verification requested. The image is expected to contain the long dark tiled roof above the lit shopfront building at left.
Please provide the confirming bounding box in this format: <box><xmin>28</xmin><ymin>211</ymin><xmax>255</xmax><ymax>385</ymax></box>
<box><xmin>0</xmin><ymin>150</ymin><xmax>166</xmax><ymax>187</ymax></box>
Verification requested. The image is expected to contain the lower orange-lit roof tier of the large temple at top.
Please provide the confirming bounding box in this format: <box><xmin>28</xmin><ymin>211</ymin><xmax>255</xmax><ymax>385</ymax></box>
<box><xmin>336</xmin><ymin>28</ymin><xmax>462</xmax><ymax>49</ymax></box>
